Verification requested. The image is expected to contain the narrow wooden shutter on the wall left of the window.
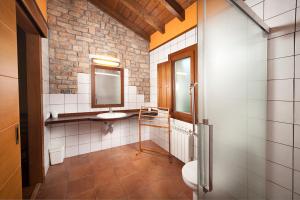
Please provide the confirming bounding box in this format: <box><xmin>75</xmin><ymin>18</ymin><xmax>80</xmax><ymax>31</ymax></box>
<box><xmin>157</xmin><ymin>62</ymin><xmax>172</xmax><ymax>108</ymax></box>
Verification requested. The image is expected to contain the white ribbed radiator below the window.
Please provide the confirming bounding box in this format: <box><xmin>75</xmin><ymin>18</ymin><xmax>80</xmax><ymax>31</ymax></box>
<box><xmin>171</xmin><ymin>123</ymin><xmax>194</xmax><ymax>163</ymax></box>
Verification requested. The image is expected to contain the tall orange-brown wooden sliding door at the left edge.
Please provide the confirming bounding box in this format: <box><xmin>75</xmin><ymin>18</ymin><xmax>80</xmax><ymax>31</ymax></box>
<box><xmin>0</xmin><ymin>0</ymin><xmax>22</xmax><ymax>199</ymax></box>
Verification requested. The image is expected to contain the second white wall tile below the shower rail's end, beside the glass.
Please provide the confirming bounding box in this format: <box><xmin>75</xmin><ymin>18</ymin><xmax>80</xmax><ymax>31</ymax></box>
<box><xmin>268</xmin><ymin>56</ymin><xmax>292</xmax><ymax>80</ymax></box>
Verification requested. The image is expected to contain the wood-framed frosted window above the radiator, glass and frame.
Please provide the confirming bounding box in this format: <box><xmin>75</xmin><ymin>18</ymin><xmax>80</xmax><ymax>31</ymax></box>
<box><xmin>169</xmin><ymin>45</ymin><xmax>197</xmax><ymax>122</ymax></box>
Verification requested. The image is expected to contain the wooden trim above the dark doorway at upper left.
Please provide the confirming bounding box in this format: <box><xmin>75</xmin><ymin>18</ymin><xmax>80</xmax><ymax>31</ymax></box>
<box><xmin>17</xmin><ymin>0</ymin><xmax>48</xmax><ymax>37</ymax></box>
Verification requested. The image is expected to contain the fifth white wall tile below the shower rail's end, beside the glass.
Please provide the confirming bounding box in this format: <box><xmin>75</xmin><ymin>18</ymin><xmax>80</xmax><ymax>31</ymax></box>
<box><xmin>267</xmin><ymin>121</ymin><xmax>293</xmax><ymax>146</ymax></box>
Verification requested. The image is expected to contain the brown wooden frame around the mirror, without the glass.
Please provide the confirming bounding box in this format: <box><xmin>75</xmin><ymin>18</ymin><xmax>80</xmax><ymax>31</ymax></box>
<box><xmin>91</xmin><ymin>64</ymin><xmax>124</xmax><ymax>108</ymax></box>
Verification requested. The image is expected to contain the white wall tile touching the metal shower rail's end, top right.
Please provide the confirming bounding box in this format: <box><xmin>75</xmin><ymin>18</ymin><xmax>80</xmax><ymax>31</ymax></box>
<box><xmin>265</xmin><ymin>10</ymin><xmax>295</xmax><ymax>38</ymax></box>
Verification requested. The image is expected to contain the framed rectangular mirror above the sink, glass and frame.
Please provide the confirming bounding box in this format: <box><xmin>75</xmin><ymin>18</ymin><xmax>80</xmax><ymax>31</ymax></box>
<box><xmin>91</xmin><ymin>65</ymin><xmax>124</xmax><ymax>108</ymax></box>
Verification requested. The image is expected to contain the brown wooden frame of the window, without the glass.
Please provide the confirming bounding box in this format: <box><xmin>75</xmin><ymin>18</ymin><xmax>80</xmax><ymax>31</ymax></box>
<box><xmin>169</xmin><ymin>44</ymin><xmax>198</xmax><ymax>123</ymax></box>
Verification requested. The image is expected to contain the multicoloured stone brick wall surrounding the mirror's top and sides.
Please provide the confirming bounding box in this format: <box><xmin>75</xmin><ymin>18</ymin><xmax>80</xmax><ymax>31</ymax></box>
<box><xmin>48</xmin><ymin>0</ymin><xmax>150</xmax><ymax>102</ymax></box>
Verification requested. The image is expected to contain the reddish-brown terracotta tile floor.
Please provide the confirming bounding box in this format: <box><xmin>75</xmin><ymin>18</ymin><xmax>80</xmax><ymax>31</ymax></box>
<box><xmin>37</xmin><ymin>141</ymin><xmax>192</xmax><ymax>200</ymax></box>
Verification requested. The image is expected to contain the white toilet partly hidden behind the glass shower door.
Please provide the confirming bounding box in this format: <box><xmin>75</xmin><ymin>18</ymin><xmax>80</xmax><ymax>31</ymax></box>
<box><xmin>182</xmin><ymin>160</ymin><xmax>198</xmax><ymax>200</ymax></box>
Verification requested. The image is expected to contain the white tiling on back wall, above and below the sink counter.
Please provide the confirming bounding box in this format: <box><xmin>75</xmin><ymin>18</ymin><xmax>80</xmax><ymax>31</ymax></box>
<box><xmin>45</xmin><ymin>69</ymin><xmax>150</xmax><ymax>157</ymax></box>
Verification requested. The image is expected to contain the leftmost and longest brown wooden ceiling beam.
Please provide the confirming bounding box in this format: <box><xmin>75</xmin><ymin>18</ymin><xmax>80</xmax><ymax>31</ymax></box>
<box><xmin>120</xmin><ymin>0</ymin><xmax>165</xmax><ymax>33</ymax></box>
